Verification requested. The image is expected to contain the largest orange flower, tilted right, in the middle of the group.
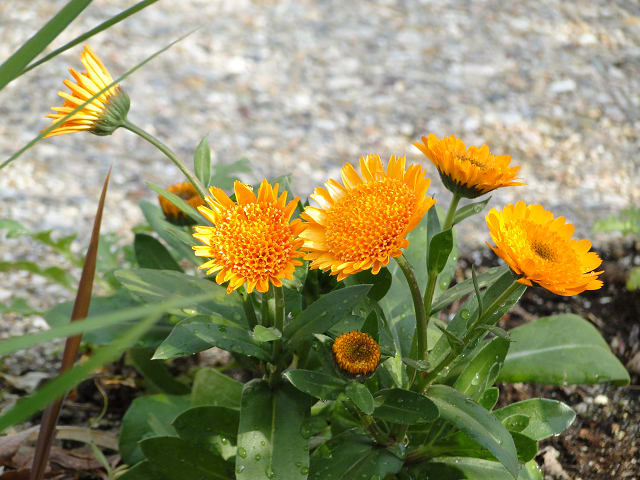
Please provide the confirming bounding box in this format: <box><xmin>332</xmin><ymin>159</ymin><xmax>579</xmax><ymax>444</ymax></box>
<box><xmin>301</xmin><ymin>155</ymin><xmax>435</xmax><ymax>280</ymax></box>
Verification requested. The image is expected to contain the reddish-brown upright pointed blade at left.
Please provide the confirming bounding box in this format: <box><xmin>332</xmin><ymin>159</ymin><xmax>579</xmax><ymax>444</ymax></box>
<box><xmin>29</xmin><ymin>167</ymin><xmax>111</xmax><ymax>480</ymax></box>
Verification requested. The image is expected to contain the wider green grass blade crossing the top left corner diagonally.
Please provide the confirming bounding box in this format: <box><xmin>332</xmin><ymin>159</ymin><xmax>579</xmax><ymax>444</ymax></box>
<box><xmin>0</xmin><ymin>0</ymin><xmax>91</xmax><ymax>90</ymax></box>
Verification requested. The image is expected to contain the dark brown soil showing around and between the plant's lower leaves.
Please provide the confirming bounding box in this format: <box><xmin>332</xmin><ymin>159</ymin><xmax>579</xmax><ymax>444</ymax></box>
<box><xmin>0</xmin><ymin>243</ymin><xmax>640</xmax><ymax>480</ymax></box>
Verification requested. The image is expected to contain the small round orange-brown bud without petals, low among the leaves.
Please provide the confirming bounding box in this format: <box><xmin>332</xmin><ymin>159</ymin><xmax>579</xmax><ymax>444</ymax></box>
<box><xmin>331</xmin><ymin>330</ymin><xmax>380</xmax><ymax>375</ymax></box>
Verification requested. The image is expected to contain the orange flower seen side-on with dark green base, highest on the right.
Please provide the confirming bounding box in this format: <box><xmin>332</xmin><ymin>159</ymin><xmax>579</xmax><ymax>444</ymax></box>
<box><xmin>414</xmin><ymin>133</ymin><xmax>524</xmax><ymax>198</ymax></box>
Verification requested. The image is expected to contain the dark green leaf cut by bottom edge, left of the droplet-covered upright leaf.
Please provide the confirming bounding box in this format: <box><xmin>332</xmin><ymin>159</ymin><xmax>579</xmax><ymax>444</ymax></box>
<box><xmin>140</xmin><ymin>437</ymin><xmax>234</xmax><ymax>480</ymax></box>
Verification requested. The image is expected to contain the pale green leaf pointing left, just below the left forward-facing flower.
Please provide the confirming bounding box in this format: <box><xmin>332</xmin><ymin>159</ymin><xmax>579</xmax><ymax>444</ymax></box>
<box><xmin>115</xmin><ymin>268</ymin><xmax>246</xmax><ymax>327</ymax></box>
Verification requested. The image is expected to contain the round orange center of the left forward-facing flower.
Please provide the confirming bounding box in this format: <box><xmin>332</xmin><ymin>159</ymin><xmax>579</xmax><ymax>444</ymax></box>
<box><xmin>210</xmin><ymin>203</ymin><xmax>295</xmax><ymax>280</ymax></box>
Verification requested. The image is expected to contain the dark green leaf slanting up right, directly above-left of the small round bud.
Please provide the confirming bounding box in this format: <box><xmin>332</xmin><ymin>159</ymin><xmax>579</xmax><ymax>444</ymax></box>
<box><xmin>284</xmin><ymin>285</ymin><xmax>371</xmax><ymax>346</ymax></box>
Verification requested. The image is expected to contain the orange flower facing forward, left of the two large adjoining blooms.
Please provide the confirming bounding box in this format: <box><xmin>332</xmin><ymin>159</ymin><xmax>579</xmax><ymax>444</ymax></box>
<box><xmin>193</xmin><ymin>180</ymin><xmax>305</xmax><ymax>293</ymax></box>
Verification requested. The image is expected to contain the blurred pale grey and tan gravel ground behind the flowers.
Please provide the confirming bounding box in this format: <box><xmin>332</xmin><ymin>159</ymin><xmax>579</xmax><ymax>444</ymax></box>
<box><xmin>0</xmin><ymin>0</ymin><xmax>640</xmax><ymax>472</ymax></box>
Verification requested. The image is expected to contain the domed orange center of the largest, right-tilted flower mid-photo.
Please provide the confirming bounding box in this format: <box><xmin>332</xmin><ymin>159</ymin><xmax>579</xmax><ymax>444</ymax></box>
<box><xmin>326</xmin><ymin>178</ymin><xmax>416</xmax><ymax>262</ymax></box>
